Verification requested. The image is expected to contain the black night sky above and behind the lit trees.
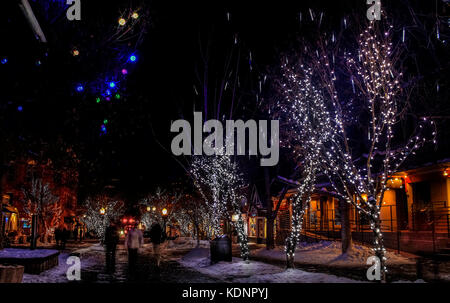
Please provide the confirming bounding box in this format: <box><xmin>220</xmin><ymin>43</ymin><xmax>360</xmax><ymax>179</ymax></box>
<box><xmin>0</xmin><ymin>0</ymin><xmax>450</xmax><ymax>204</ymax></box>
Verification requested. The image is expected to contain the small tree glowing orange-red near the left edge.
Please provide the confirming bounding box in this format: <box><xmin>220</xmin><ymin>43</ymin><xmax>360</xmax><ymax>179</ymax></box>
<box><xmin>22</xmin><ymin>177</ymin><xmax>63</xmax><ymax>243</ymax></box>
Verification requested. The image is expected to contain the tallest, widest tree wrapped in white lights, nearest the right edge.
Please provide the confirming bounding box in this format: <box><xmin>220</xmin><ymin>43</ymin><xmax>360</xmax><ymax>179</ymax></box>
<box><xmin>276</xmin><ymin>18</ymin><xmax>436</xmax><ymax>280</ymax></box>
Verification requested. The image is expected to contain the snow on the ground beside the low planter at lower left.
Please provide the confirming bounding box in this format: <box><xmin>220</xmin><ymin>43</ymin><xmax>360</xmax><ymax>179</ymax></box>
<box><xmin>22</xmin><ymin>244</ymin><xmax>103</xmax><ymax>283</ymax></box>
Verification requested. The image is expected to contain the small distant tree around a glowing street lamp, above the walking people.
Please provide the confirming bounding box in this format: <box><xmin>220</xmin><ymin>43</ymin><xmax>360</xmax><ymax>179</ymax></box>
<box><xmin>82</xmin><ymin>195</ymin><xmax>125</xmax><ymax>241</ymax></box>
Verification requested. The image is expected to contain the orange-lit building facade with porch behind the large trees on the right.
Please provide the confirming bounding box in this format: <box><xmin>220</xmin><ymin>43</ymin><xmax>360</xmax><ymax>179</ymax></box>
<box><xmin>274</xmin><ymin>162</ymin><xmax>450</xmax><ymax>253</ymax></box>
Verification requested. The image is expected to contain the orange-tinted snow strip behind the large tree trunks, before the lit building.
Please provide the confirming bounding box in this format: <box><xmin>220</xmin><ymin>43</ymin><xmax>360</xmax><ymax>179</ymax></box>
<box><xmin>251</xmin><ymin>241</ymin><xmax>415</xmax><ymax>266</ymax></box>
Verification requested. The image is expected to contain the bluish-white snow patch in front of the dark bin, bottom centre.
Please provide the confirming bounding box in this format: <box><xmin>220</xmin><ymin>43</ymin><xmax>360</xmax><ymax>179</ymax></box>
<box><xmin>179</xmin><ymin>248</ymin><xmax>360</xmax><ymax>283</ymax></box>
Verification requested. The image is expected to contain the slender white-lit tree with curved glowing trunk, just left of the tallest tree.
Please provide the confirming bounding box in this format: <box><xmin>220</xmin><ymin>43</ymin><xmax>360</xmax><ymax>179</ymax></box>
<box><xmin>276</xmin><ymin>66</ymin><xmax>334</xmax><ymax>268</ymax></box>
